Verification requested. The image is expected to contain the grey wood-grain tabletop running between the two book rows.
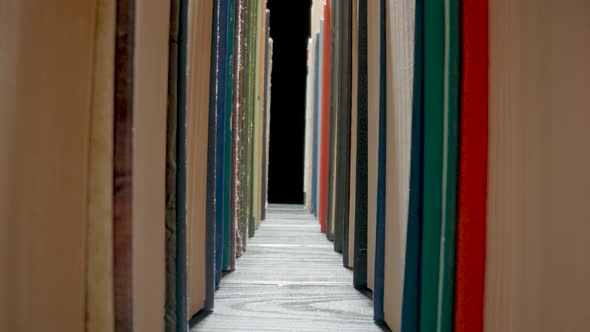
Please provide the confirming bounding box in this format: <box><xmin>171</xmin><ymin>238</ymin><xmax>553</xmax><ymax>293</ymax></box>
<box><xmin>191</xmin><ymin>205</ymin><xmax>381</xmax><ymax>332</ymax></box>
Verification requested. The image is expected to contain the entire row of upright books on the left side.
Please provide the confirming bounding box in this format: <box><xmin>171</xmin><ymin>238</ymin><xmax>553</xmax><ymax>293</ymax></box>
<box><xmin>0</xmin><ymin>0</ymin><xmax>272</xmax><ymax>332</ymax></box>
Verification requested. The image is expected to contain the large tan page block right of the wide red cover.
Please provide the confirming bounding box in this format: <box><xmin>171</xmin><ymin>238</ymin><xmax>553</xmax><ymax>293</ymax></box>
<box><xmin>484</xmin><ymin>0</ymin><xmax>590</xmax><ymax>332</ymax></box>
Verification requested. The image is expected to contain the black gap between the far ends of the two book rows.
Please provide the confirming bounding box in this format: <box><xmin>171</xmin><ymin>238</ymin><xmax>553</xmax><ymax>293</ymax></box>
<box><xmin>268</xmin><ymin>0</ymin><xmax>311</xmax><ymax>204</ymax></box>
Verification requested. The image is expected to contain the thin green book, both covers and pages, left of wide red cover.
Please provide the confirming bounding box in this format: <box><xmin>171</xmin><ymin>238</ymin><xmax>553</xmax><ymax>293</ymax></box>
<box><xmin>420</xmin><ymin>0</ymin><xmax>460</xmax><ymax>331</ymax></box>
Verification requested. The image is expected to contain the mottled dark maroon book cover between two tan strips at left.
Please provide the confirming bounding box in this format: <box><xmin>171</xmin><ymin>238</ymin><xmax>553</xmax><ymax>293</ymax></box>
<box><xmin>113</xmin><ymin>0</ymin><xmax>137</xmax><ymax>331</ymax></box>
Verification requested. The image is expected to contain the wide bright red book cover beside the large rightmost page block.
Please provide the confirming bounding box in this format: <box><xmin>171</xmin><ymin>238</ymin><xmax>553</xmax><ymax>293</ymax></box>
<box><xmin>455</xmin><ymin>0</ymin><xmax>489</xmax><ymax>332</ymax></box>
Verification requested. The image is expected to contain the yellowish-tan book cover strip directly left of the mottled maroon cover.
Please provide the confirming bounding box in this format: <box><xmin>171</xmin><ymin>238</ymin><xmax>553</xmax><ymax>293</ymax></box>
<box><xmin>86</xmin><ymin>0</ymin><xmax>116</xmax><ymax>332</ymax></box>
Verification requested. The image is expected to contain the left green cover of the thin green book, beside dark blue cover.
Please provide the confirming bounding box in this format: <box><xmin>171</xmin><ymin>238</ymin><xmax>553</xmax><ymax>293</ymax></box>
<box><xmin>420</xmin><ymin>0</ymin><xmax>445</xmax><ymax>326</ymax></box>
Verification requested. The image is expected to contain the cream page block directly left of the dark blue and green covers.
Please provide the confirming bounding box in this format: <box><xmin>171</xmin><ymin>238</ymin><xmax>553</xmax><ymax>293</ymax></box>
<box><xmin>384</xmin><ymin>0</ymin><xmax>415</xmax><ymax>331</ymax></box>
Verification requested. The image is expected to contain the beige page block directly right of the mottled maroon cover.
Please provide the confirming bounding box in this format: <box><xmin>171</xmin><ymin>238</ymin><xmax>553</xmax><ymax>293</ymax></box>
<box><xmin>132</xmin><ymin>0</ymin><xmax>170</xmax><ymax>332</ymax></box>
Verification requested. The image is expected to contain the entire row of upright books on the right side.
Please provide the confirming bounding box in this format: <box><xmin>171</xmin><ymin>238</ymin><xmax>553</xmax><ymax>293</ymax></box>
<box><xmin>304</xmin><ymin>0</ymin><xmax>590</xmax><ymax>332</ymax></box>
